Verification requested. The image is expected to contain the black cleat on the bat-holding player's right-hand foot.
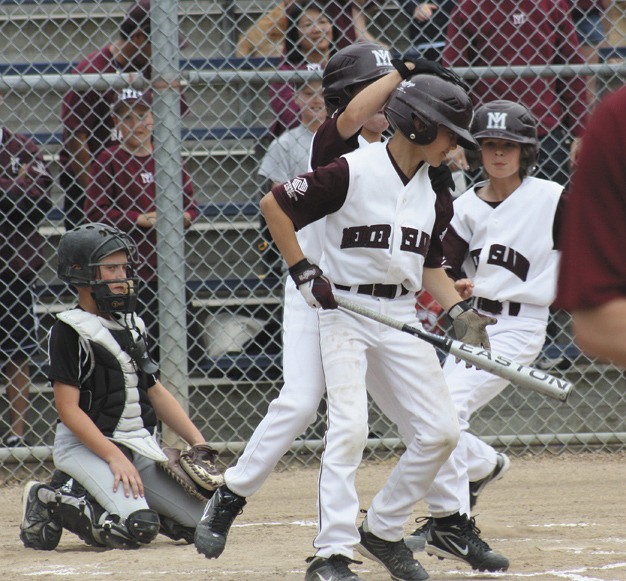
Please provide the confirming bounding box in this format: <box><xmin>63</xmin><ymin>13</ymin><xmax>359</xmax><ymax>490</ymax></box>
<box><xmin>355</xmin><ymin>521</ymin><xmax>429</xmax><ymax>581</ymax></box>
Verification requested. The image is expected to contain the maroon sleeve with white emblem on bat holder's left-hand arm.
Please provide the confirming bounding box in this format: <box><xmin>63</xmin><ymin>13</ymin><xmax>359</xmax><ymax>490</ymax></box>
<box><xmin>272</xmin><ymin>157</ymin><xmax>350</xmax><ymax>230</ymax></box>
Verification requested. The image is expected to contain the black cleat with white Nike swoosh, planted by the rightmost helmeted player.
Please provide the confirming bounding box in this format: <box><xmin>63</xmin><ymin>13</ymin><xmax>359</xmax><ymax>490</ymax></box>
<box><xmin>426</xmin><ymin>516</ymin><xmax>509</xmax><ymax>572</ymax></box>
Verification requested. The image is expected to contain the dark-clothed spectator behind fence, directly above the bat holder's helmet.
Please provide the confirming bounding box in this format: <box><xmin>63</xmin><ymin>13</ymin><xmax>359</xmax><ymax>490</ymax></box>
<box><xmin>400</xmin><ymin>0</ymin><xmax>457</xmax><ymax>61</ymax></box>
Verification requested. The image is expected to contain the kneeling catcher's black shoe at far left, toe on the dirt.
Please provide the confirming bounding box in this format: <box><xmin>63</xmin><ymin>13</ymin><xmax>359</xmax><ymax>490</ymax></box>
<box><xmin>20</xmin><ymin>480</ymin><xmax>63</xmax><ymax>551</ymax></box>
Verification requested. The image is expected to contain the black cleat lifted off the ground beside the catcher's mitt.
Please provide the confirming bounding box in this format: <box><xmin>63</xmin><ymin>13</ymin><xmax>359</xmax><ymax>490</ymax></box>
<box><xmin>194</xmin><ymin>485</ymin><xmax>246</xmax><ymax>559</ymax></box>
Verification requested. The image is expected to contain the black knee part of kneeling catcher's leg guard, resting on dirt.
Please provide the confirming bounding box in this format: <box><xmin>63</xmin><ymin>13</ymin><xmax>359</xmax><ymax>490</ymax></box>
<box><xmin>102</xmin><ymin>508</ymin><xmax>160</xmax><ymax>549</ymax></box>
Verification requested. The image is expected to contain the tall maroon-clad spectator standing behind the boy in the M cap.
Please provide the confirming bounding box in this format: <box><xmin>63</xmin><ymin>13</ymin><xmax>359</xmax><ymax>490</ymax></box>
<box><xmin>60</xmin><ymin>0</ymin><xmax>186</xmax><ymax>228</ymax></box>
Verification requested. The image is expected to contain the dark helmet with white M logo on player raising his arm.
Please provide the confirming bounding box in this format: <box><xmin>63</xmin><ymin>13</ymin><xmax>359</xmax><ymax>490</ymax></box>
<box><xmin>322</xmin><ymin>42</ymin><xmax>395</xmax><ymax>112</ymax></box>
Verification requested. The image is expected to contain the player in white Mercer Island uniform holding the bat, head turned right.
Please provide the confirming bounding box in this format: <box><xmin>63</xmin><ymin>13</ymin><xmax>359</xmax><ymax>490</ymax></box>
<box><xmin>261</xmin><ymin>75</ymin><xmax>494</xmax><ymax>580</ymax></box>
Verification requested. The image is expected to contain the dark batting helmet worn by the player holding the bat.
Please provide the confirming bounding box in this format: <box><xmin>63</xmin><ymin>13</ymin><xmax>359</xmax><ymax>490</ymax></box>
<box><xmin>385</xmin><ymin>75</ymin><xmax>479</xmax><ymax>149</ymax></box>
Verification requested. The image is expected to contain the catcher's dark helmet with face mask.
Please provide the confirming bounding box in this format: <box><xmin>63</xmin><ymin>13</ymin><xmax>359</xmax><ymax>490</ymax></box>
<box><xmin>57</xmin><ymin>223</ymin><xmax>137</xmax><ymax>313</ymax></box>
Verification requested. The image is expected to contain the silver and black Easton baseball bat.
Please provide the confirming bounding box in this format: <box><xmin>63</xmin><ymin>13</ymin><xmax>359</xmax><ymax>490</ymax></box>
<box><xmin>335</xmin><ymin>295</ymin><xmax>573</xmax><ymax>402</ymax></box>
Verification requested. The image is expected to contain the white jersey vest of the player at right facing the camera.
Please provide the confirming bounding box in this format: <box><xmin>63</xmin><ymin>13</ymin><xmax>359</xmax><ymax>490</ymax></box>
<box><xmin>450</xmin><ymin>177</ymin><xmax>563</xmax><ymax>306</ymax></box>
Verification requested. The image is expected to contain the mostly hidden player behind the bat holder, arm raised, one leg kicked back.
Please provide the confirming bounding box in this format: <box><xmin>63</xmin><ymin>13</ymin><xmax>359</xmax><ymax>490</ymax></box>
<box><xmin>196</xmin><ymin>43</ymin><xmax>470</xmax><ymax>579</ymax></box>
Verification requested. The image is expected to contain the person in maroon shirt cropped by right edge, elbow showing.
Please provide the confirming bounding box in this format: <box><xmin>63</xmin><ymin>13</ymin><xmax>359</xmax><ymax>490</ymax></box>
<box><xmin>556</xmin><ymin>87</ymin><xmax>626</xmax><ymax>367</ymax></box>
